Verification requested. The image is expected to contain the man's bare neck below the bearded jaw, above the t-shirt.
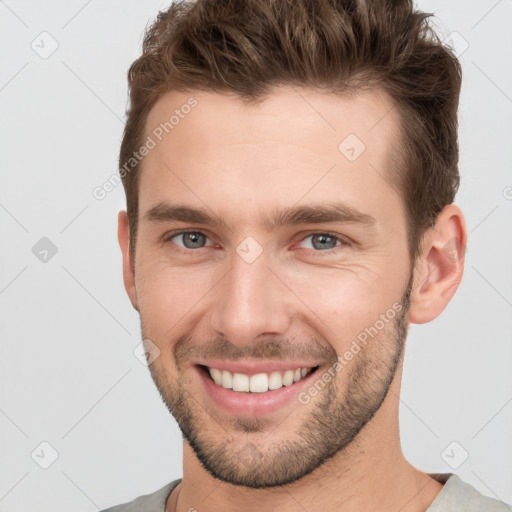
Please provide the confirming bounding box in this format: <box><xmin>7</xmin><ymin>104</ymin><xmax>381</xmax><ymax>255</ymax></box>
<box><xmin>168</xmin><ymin>364</ymin><xmax>442</xmax><ymax>512</ymax></box>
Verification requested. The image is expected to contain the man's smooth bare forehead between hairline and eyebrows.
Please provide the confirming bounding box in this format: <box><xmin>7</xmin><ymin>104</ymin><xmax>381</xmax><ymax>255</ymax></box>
<box><xmin>139</xmin><ymin>87</ymin><xmax>398</xmax><ymax>227</ymax></box>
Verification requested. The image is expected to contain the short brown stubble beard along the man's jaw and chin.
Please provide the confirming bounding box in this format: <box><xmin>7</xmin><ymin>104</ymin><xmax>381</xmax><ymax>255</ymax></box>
<box><xmin>142</xmin><ymin>276</ymin><xmax>412</xmax><ymax>489</ymax></box>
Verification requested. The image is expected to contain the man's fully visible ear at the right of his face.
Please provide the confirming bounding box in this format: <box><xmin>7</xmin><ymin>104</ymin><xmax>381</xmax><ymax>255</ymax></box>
<box><xmin>409</xmin><ymin>203</ymin><xmax>467</xmax><ymax>324</ymax></box>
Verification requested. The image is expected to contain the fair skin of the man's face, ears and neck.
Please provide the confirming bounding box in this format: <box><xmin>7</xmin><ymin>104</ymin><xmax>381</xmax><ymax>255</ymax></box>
<box><xmin>118</xmin><ymin>87</ymin><xmax>467</xmax><ymax>512</ymax></box>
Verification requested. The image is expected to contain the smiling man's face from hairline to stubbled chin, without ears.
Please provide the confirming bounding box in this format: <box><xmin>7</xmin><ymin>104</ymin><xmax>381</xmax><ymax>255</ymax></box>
<box><xmin>130</xmin><ymin>88</ymin><xmax>411</xmax><ymax>487</ymax></box>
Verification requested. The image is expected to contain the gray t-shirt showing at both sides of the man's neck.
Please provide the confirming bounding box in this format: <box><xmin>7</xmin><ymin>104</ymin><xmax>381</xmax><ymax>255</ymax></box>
<box><xmin>102</xmin><ymin>473</ymin><xmax>512</xmax><ymax>512</ymax></box>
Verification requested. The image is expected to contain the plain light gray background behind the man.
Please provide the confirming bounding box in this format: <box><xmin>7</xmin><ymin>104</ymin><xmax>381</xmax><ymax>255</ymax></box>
<box><xmin>0</xmin><ymin>0</ymin><xmax>512</xmax><ymax>512</ymax></box>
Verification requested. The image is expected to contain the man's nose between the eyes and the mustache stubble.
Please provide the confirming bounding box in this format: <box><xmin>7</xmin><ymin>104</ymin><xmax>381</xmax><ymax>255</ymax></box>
<box><xmin>210</xmin><ymin>244</ymin><xmax>291</xmax><ymax>347</ymax></box>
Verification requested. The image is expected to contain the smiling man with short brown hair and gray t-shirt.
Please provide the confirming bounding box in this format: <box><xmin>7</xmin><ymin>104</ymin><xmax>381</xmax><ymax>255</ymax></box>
<box><xmin>103</xmin><ymin>0</ymin><xmax>508</xmax><ymax>512</ymax></box>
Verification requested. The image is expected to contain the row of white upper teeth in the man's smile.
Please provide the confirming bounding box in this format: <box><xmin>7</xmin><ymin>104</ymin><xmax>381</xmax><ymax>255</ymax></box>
<box><xmin>208</xmin><ymin>368</ymin><xmax>311</xmax><ymax>393</ymax></box>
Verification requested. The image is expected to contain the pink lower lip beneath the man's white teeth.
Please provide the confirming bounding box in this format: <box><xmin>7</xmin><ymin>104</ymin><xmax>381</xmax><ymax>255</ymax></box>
<box><xmin>196</xmin><ymin>366</ymin><xmax>318</xmax><ymax>416</ymax></box>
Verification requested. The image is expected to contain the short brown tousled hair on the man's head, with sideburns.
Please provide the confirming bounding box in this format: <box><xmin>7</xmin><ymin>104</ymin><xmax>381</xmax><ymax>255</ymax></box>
<box><xmin>119</xmin><ymin>0</ymin><xmax>461</xmax><ymax>263</ymax></box>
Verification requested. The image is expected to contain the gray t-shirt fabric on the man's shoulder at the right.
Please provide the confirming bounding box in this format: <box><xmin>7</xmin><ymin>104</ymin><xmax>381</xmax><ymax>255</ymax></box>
<box><xmin>426</xmin><ymin>473</ymin><xmax>512</xmax><ymax>512</ymax></box>
